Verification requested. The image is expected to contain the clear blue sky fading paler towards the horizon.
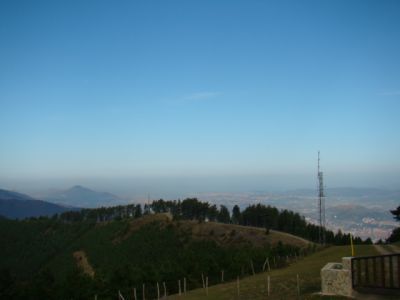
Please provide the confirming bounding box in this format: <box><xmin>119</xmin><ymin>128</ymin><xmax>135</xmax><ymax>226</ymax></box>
<box><xmin>0</xmin><ymin>0</ymin><xmax>400</xmax><ymax>189</ymax></box>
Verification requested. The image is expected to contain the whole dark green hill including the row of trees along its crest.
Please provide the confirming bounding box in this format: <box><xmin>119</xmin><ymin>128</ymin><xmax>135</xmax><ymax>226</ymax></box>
<box><xmin>0</xmin><ymin>199</ymin><xmax>368</xmax><ymax>299</ymax></box>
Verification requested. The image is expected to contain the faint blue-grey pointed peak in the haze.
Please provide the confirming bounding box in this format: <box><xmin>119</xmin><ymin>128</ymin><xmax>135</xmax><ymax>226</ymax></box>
<box><xmin>42</xmin><ymin>185</ymin><xmax>124</xmax><ymax>208</ymax></box>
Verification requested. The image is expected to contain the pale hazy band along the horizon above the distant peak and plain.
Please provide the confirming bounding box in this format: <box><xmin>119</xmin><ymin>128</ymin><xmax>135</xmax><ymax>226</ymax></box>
<box><xmin>0</xmin><ymin>172</ymin><xmax>399</xmax><ymax>200</ymax></box>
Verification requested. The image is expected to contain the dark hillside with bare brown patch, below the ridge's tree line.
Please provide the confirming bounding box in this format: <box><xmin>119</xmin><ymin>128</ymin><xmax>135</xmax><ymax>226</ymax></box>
<box><xmin>0</xmin><ymin>214</ymin><xmax>312</xmax><ymax>299</ymax></box>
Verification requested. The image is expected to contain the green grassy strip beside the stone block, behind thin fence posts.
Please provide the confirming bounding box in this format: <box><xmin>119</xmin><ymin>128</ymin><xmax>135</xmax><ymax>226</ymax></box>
<box><xmin>170</xmin><ymin>246</ymin><xmax>378</xmax><ymax>300</ymax></box>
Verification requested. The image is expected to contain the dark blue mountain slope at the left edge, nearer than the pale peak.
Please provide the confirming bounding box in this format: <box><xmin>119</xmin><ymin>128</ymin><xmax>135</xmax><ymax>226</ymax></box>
<box><xmin>0</xmin><ymin>189</ymin><xmax>71</xmax><ymax>219</ymax></box>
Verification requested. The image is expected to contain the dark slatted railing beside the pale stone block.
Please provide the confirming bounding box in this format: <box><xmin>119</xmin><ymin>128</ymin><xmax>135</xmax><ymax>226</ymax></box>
<box><xmin>351</xmin><ymin>253</ymin><xmax>400</xmax><ymax>293</ymax></box>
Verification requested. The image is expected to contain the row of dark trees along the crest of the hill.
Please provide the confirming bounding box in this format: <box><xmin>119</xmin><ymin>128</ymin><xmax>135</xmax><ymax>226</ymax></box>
<box><xmin>47</xmin><ymin>198</ymin><xmax>372</xmax><ymax>245</ymax></box>
